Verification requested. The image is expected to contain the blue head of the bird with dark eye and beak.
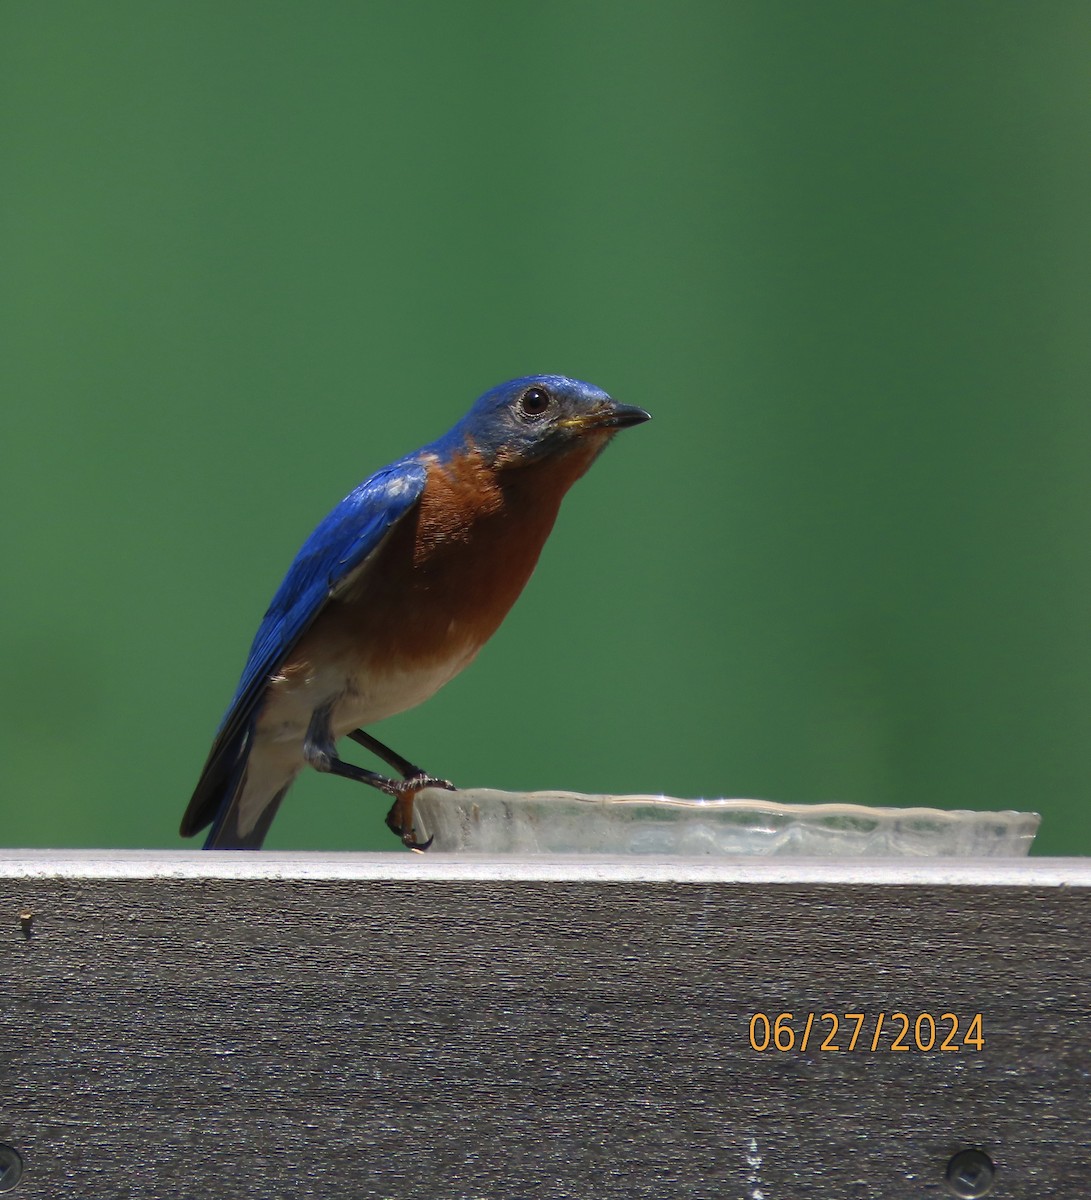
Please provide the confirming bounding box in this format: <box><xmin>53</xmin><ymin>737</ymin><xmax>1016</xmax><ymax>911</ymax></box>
<box><xmin>434</xmin><ymin>376</ymin><xmax>649</xmax><ymax>468</ymax></box>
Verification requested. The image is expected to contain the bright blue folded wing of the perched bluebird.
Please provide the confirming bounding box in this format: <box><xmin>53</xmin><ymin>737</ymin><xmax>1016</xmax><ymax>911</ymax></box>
<box><xmin>181</xmin><ymin>458</ymin><xmax>427</xmax><ymax>834</ymax></box>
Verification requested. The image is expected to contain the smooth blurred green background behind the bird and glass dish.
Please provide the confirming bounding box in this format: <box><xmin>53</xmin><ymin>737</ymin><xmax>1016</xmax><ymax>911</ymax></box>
<box><xmin>0</xmin><ymin>0</ymin><xmax>1091</xmax><ymax>853</ymax></box>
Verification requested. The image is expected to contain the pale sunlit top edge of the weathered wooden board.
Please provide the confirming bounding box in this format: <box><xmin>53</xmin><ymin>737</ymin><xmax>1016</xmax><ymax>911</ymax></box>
<box><xmin>0</xmin><ymin>850</ymin><xmax>1091</xmax><ymax>888</ymax></box>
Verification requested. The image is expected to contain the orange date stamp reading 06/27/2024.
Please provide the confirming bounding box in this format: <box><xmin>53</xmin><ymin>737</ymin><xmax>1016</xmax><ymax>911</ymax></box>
<box><xmin>750</xmin><ymin>1012</ymin><xmax>985</xmax><ymax>1054</ymax></box>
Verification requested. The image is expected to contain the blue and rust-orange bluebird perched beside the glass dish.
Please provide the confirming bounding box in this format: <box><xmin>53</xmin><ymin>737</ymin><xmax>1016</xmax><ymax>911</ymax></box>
<box><xmin>181</xmin><ymin>376</ymin><xmax>648</xmax><ymax>850</ymax></box>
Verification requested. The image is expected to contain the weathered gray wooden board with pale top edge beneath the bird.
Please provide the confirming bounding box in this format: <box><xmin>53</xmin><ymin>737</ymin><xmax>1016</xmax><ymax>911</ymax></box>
<box><xmin>0</xmin><ymin>852</ymin><xmax>1091</xmax><ymax>1200</ymax></box>
